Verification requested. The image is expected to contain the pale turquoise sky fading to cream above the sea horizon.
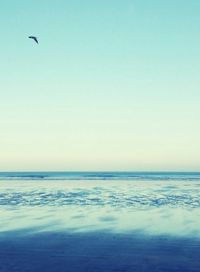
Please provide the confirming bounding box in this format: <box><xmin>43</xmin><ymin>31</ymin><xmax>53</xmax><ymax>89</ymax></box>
<box><xmin>0</xmin><ymin>0</ymin><xmax>200</xmax><ymax>171</ymax></box>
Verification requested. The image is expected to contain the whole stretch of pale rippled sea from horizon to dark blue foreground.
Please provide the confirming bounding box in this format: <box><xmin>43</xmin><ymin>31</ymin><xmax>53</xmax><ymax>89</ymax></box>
<box><xmin>0</xmin><ymin>172</ymin><xmax>200</xmax><ymax>238</ymax></box>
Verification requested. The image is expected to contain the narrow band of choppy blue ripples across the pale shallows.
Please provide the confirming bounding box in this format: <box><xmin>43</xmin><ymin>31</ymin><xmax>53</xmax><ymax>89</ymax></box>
<box><xmin>0</xmin><ymin>190</ymin><xmax>200</xmax><ymax>209</ymax></box>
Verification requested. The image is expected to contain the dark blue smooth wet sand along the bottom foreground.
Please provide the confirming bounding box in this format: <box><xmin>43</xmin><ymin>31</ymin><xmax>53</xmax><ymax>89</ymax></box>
<box><xmin>0</xmin><ymin>232</ymin><xmax>200</xmax><ymax>272</ymax></box>
